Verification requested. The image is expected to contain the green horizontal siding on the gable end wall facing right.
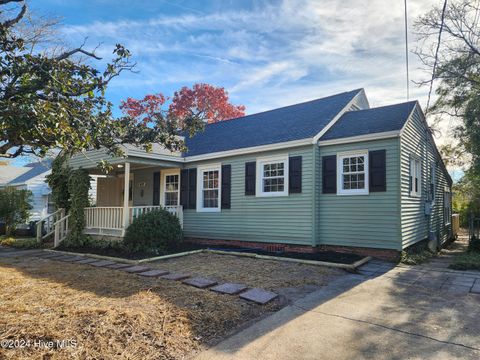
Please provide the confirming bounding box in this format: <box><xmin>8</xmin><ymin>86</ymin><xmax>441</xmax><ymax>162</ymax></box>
<box><xmin>401</xmin><ymin>108</ymin><xmax>450</xmax><ymax>248</ymax></box>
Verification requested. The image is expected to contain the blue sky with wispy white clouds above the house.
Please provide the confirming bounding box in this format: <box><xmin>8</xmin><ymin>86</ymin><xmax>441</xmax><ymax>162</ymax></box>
<box><xmin>16</xmin><ymin>0</ymin><xmax>464</xmax><ymax>179</ymax></box>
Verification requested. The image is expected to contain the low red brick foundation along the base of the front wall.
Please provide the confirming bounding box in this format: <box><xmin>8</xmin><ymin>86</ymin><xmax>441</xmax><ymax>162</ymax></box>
<box><xmin>185</xmin><ymin>238</ymin><xmax>400</xmax><ymax>262</ymax></box>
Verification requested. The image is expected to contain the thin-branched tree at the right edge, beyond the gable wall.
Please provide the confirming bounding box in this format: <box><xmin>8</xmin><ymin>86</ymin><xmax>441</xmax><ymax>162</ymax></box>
<box><xmin>415</xmin><ymin>0</ymin><xmax>480</xmax><ymax>220</ymax></box>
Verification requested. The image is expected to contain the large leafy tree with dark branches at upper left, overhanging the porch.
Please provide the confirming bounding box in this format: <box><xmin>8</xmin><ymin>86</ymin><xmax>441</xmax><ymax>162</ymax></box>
<box><xmin>0</xmin><ymin>0</ymin><xmax>201</xmax><ymax>158</ymax></box>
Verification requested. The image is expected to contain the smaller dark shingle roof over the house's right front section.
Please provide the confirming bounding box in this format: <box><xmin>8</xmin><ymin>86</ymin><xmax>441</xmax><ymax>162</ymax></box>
<box><xmin>320</xmin><ymin>101</ymin><xmax>417</xmax><ymax>141</ymax></box>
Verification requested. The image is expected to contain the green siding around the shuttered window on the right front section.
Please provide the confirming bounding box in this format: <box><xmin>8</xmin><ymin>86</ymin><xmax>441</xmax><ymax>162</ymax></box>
<box><xmin>315</xmin><ymin>138</ymin><xmax>401</xmax><ymax>250</ymax></box>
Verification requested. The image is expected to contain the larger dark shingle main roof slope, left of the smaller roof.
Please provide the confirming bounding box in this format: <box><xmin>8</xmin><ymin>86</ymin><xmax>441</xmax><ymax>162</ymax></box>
<box><xmin>184</xmin><ymin>89</ymin><xmax>362</xmax><ymax>156</ymax></box>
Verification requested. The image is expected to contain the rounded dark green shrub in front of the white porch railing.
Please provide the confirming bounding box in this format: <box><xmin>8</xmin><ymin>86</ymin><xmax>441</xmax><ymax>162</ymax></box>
<box><xmin>124</xmin><ymin>209</ymin><xmax>183</xmax><ymax>254</ymax></box>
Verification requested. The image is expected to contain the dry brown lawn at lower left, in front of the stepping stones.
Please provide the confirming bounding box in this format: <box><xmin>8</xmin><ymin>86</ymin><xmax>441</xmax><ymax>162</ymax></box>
<box><xmin>0</xmin><ymin>258</ymin><xmax>280</xmax><ymax>359</ymax></box>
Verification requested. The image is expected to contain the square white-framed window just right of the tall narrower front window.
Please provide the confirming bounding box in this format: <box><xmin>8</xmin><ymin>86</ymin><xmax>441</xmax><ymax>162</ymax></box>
<box><xmin>257</xmin><ymin>156</ymin><xmax>288</xmax><ymax>196</ymax></box>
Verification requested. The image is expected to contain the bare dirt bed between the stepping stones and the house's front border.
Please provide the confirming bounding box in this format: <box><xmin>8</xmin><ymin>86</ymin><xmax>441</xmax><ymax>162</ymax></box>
<box><xmin>147</xmin><ymin>253</ymin><xmax>345</xmax><ymax>290</ymax></box>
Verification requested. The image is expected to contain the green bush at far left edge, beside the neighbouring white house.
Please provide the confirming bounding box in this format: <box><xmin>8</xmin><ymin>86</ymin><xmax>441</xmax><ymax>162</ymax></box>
<box><xmin>0</xmin><ymin>186</ymin><xmax>32</xmax><ymax>236</ymax></box>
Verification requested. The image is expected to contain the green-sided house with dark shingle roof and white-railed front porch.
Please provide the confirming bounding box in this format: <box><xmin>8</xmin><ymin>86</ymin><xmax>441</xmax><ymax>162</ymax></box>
<box><xmin>70</xmin><ymin>89</ymin><xmax>452</xmax><ymax>258</ymax></box>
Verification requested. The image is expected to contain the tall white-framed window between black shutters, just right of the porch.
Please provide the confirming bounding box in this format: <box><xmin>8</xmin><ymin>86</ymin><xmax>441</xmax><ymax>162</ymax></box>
<box><xmin>197</xmin><ymin>165</ymin><xmax>221</xmax><ymax>212</ymax></box>
